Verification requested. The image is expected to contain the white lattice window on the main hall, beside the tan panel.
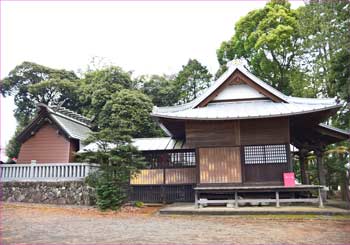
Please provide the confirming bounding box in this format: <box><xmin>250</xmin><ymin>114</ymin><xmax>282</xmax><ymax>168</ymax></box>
<box><xmin>244</xmin><ymin>145</ymin><xmax>287</xmax><ymax>164</ymax></box>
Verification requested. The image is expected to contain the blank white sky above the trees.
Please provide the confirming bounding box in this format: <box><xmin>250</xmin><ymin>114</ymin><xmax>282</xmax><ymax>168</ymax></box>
<box><xmin>0</xmin><ymin>1</ymin><xmax>303</xmax><ymax>159</ymax></box>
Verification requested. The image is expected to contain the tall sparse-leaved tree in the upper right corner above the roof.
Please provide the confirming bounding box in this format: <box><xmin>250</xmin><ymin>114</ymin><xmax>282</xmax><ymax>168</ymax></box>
<box><xmin>298</xmin><ymin>1</ymin><xmax>350</xmax><ymax>97</ymax></box>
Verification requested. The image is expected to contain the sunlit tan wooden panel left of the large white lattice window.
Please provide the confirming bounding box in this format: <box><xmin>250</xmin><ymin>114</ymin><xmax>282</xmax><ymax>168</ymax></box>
<box><xmin>199</xmin><ymin>147</ymin><xmax>242</xmax><ymax>183</ymax></box>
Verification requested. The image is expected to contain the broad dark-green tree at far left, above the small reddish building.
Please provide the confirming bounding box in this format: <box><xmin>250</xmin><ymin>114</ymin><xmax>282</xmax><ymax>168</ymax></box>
<box><xmin>0</xmin><ymin>62</ymin><xmax>79</xmax><ymax>126</ymax></box>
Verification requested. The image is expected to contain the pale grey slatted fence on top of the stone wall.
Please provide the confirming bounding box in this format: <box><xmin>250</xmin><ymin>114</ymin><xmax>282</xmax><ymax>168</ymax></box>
<box><xmin>0</xmin><ymin>163</ymin><xmax>97</xmax><ymax>182</ymax></box>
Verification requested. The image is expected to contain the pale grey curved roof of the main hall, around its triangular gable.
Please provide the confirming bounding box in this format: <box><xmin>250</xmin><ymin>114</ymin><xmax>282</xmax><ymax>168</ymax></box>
<box><xmin>151</xmin><ymin>63</ymin><xmax>341</xmax><ymax>120</ymax></box>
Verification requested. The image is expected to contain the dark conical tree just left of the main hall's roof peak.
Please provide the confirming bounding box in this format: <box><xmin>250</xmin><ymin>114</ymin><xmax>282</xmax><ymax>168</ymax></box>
<box><xmin>175</xmin><ymin>59</ymin><xmax>212</xmax><ymax>103</ymax></box>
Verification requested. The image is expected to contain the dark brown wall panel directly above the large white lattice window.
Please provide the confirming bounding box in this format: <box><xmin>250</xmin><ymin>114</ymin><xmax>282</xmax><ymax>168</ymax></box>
<box><xmin>240</xmin><ymin>117</ymin><xmax>290</xmax><ymax>145</ymax></box>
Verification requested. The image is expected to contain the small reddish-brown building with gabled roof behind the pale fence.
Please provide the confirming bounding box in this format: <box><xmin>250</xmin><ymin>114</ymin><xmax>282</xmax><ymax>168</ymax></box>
<box><xmin>17</xmin><ymin>104</ymin><xmax>91</xmax><ymax>163</ymax></box>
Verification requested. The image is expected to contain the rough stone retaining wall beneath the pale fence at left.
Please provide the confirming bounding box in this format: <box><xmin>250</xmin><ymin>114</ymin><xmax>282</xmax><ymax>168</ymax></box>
<box><xmin>1</xmin><ymin>181</ymin><xmax>96</xmax><ymax>205</ymax></box>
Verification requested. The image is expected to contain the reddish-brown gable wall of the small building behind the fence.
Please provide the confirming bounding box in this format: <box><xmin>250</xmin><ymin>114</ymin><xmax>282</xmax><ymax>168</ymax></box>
<box><xmin>17</xmin><ymin>124</ymin><xmax>71</xmax><ymax>163</ymax></box>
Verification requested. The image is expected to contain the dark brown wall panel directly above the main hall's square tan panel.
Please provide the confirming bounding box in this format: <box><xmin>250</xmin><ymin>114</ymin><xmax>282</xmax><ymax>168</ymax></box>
<box><xmin>186</xmin><ymin>121</ymin><xmax>240</xmax><ymax>147</ymax></box>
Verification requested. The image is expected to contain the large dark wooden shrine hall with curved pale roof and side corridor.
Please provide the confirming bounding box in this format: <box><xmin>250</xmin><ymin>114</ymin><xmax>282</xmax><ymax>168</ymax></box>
<box><xmin>82</xmin><ymin>63</ymin><xmax>349</xmax><ymax>206</ymax></box>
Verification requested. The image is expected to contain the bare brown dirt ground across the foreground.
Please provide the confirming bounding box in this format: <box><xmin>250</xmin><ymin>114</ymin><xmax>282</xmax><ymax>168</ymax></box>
<box><xmin>0</xmin><ymin>203</ymin><xmax>350</xmax><ymax>244</ymax></box>
